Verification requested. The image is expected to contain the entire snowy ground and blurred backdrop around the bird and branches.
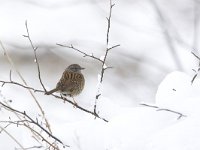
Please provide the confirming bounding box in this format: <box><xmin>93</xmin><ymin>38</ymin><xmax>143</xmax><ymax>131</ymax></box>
<box><xmin>0</xmin><ymin>0</ymin><xmax>200</xmax><ymax>150</ymax></box>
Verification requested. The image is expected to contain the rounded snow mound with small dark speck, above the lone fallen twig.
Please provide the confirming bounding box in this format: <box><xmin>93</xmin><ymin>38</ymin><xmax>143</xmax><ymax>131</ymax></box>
<box><xmin>156</xmin><ymin>72</ymin><xmax>200</xmax><ymax>115</ymax></box>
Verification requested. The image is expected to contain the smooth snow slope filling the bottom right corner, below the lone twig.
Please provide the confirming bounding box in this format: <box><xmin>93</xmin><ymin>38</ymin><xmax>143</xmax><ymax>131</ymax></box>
<box><xmin>146</xmin><ymin>117</ymin><xmax>200</xmax><ymax>150</ymax></box>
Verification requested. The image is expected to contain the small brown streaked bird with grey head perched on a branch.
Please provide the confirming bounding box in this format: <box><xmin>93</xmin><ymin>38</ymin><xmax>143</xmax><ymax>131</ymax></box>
<box><xmin>46</xmin><ymin>64</ymin><xmax>85</xmax><ymax>98</ymax></box>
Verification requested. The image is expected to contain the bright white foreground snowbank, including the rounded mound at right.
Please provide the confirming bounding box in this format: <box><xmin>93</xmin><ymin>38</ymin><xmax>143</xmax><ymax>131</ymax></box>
<box><xmin>0</xmin><ymin>71</ymin><xmax>200</xmax><ymax>150</ymax></box>
